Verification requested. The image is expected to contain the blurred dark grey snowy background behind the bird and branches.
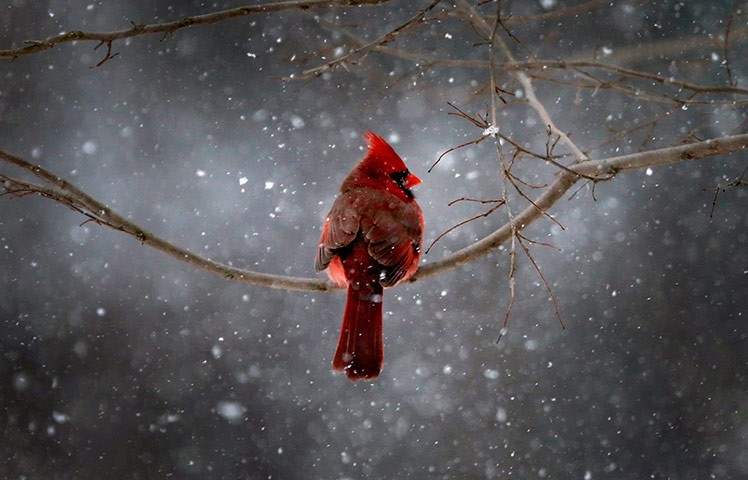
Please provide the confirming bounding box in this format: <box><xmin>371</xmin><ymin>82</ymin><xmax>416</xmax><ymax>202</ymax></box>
<box><xmin>0</xmin><ymin>0</ymin><xmax>748</xmax><ymax>480</ymax></box>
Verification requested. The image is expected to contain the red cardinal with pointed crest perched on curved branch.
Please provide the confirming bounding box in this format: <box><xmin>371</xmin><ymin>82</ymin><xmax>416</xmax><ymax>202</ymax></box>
<box><xmin>315</xmin><ymin>132</ymin><xmax>423</xmax><ymax>381</ymax></box>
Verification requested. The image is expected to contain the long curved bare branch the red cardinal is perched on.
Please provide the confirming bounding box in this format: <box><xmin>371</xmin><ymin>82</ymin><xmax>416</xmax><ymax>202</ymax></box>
<box><xmin>0</xmin><ymin>134</ymin><xmax>748</xmax><ymax>292</ymax></box>
